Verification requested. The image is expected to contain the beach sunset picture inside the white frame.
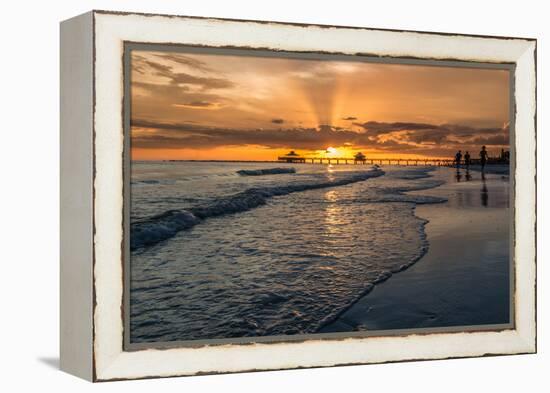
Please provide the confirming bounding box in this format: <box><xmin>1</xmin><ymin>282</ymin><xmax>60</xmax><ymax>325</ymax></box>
<box><xmin>129</xmin><ymin>47</ymin><xmax>513</xmax><ymax>344</ymax></box>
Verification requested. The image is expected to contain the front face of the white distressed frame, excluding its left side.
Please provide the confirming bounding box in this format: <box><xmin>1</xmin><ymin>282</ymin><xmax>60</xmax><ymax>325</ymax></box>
<box><xmin>80</xmin><ymin>12</ymin><xmax>536</xmax><ymax>380</ymax></box>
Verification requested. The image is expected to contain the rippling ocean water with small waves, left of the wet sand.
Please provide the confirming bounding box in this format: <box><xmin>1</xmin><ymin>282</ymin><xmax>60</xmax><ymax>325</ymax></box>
<box><xmin>130</xmin><ymin>162</ymin><xmax>445</xmax><ymax>343</ymax></box>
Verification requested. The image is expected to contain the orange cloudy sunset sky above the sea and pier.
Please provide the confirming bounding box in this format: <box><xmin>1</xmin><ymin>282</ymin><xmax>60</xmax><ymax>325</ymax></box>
<box><xmin>131</xmin><ymin>51</ymin><xmax>510</xmax><ymax>160</ymax></box>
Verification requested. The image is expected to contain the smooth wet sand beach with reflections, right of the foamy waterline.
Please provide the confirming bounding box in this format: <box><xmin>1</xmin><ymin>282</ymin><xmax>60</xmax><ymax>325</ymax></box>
<box><xmin>321</xmin><ymin>168</ymin><xmax>511</xmax><ymax>333</ymax></box>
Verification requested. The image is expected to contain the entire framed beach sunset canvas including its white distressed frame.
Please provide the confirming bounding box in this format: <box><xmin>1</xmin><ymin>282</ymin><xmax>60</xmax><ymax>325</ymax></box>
<box><xmin>61</xmin><ymin>11</ymin><xmax>536</xmax><ymax>381</ymax></box>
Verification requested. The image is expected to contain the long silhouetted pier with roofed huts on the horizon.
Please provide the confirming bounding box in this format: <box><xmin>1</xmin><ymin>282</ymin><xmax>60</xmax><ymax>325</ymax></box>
<box><xmin>278</xmin><ymin>155</ymin><xmax>456</xmax><ymax>166</ymax></box>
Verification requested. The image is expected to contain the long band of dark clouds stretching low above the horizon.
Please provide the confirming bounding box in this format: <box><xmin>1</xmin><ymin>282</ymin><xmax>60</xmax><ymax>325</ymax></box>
<box><xmin>132</xmin><ymin>119</ymin><xmax>509</xmax><ymax>155</ymax></box>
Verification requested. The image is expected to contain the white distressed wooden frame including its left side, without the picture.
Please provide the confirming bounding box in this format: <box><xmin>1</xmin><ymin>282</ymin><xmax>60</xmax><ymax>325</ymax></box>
<box><xmin>60</xmin><ymin>11</ymin><xmax>536</xmax><ymax>381</ymax></box>
